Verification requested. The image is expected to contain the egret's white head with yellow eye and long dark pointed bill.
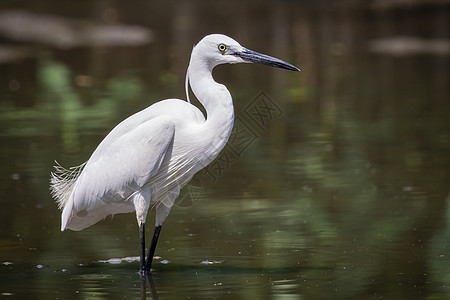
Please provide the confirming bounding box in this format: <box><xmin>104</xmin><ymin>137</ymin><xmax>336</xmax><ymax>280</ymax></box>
<box><xmin>191</xmin><ymin>34</ymin><xmax>300</xmax><ymax>71</ymax></box>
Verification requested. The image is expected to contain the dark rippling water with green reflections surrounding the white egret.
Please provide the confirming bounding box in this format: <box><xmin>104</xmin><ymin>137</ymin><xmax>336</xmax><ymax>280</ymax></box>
<box><xmin>0</xmin><ymin>1</ymin><xmax>450</xmax><ymax>299</ymax></box>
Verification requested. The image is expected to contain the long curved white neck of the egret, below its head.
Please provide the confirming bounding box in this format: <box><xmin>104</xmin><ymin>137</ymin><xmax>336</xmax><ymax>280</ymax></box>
<box><xmin>188</xmin><ymin>50</ymin><xmax>234</xmax><ymax>160</ymax></box>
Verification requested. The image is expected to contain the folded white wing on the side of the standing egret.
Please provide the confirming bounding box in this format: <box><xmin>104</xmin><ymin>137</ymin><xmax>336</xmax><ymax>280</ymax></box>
<box><xmin>72</xmin><ymin>116</ymin><xmax>175</xmax><ymax>211</ymax></box>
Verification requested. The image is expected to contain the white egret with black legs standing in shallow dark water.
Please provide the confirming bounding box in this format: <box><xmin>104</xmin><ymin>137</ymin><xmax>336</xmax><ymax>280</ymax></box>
<box><xmin>50</xmin><ymin>34</ymin><xmax>300</xmax><ymax>273</ymax></box>
